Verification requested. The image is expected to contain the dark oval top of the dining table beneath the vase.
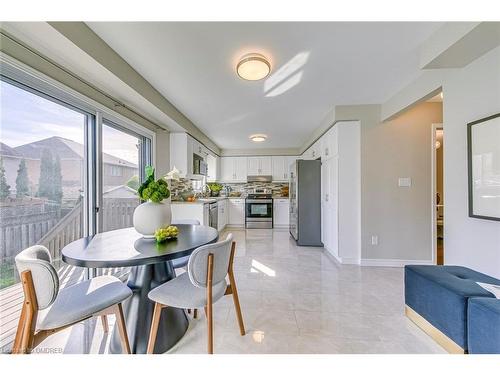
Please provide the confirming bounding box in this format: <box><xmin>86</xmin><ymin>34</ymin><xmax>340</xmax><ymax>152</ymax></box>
<box><xmin>62</xmin><ymin>224</ymin><xmax>219</xmax><ymax>268</ymax></box>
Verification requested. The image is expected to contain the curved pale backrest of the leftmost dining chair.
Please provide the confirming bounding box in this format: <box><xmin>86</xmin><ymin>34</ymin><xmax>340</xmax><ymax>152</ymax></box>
<box><xmin>15</xmin><ymin>245</ymin><xmax>59</xmax><ymax>309</ymax></box>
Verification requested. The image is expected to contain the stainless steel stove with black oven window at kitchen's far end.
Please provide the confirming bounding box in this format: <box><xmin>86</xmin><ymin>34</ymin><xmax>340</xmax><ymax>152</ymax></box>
<box><xmin>245</xmin><ymin>189</ymin><xmax>273</xmax><ymax>229</ymax></box>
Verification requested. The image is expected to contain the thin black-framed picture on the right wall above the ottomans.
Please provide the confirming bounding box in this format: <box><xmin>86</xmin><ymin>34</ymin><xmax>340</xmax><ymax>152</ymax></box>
<box><xmin>467</xmin><ymin>113</ymin><xmax>500</xmax><ymax>221</ymax></box>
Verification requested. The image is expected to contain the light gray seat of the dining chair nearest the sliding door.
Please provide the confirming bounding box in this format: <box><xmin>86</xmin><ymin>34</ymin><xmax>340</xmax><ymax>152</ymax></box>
<box><xmin>37</xmin><ymin>276</ymin><xmax>132</xmax><ymax>330</ymax></box>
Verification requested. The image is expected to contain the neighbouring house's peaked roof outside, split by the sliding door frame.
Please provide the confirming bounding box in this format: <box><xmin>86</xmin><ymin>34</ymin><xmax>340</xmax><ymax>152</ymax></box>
<box><xmin>12</xmin><ymin>136</ymin><xmax>137</xmax><ymax>168</ymax></box>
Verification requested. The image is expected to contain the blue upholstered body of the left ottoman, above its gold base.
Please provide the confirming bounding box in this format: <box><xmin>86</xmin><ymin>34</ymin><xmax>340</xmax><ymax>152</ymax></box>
<box><xmin>405</xmin><ymin>265</ymin><xmax>500</xmax><ymax>350</ymax></box>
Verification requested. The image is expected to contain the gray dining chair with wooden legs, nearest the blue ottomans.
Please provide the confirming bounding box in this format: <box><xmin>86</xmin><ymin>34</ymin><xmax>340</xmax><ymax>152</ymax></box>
<box><xmin>147</xmin><ymin>233</ymin><xmax>245</xmax><ymax>354</ymax></box>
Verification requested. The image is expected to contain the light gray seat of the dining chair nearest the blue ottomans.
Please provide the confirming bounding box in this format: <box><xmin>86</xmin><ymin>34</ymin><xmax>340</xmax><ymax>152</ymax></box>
<box><xmin>148</xmin><ymin>272</ymin><xmax>227</xmax><ymax>309</ymax></box>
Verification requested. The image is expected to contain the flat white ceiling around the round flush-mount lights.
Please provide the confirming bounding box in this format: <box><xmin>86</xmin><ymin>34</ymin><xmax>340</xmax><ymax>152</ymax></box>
<box><xmin>88</xmin><ymin>22</ymin><xmax>441</xmax><ymax>149</ymax></box>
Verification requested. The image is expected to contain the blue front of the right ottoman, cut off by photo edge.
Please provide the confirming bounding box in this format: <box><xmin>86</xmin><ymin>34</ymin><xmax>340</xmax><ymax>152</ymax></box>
<box><xmin>467</xmin><ymin>297</ymin><xmax>500</xmax><ymax>354</ymax></box>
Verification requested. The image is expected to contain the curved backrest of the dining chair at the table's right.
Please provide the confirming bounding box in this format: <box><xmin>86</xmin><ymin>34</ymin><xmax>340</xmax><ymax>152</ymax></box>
<box><xmin>188</xmin><ymin>233</ymin><xmax>233</xmax><ymax>288</ymax></box>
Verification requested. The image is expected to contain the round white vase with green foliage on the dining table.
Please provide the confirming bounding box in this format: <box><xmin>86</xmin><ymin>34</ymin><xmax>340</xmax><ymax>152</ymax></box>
<box><xmin>133</xmin><ymin>166</ymin><xmax>172</xmax><ymax>238</ymax></box>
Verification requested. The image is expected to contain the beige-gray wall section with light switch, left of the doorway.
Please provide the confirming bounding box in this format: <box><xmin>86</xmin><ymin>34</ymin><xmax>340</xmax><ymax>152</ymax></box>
<box><xmin>361</xmin><ymin>103</ymin><xmax>442</xmax><ymax>261</ymax></box>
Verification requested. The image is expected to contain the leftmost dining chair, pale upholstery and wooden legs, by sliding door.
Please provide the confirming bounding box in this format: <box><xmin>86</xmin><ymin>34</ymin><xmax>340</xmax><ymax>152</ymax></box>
<box><xmin>12</xmin><ymin>245</ymin><xmax>132</xmax><ymax>354</ymax></box>
